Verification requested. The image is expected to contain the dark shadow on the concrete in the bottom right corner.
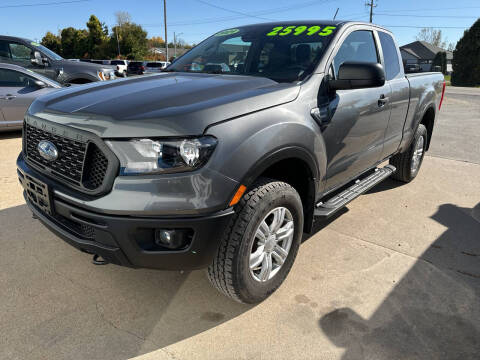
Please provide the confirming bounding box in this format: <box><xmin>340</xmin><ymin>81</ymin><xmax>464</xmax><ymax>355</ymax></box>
<box><xmin>319</xmin><ymin>204</ymin><xmax>480</xmax><ymax>360</ymax></box>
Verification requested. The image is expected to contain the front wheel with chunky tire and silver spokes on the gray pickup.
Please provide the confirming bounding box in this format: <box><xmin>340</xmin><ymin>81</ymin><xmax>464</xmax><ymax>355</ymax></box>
<box><xmin>207</xmin><ymin>178</ymin><xmax>303</xmax><ymax>304</ymax></box>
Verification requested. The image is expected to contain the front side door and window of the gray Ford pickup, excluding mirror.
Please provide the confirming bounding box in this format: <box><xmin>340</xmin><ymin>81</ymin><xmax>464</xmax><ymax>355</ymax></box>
<box><xmin>323</xmin><ymin>30</ymin><xmax>391</xmax><ymax>190</ymax></box>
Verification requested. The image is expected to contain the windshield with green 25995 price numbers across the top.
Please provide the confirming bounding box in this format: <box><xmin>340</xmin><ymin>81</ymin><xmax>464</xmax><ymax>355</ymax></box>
<box><xmin>166</xmin><ymin>23</ymin><xmax>336</xmax><ymax>82</ymax></box>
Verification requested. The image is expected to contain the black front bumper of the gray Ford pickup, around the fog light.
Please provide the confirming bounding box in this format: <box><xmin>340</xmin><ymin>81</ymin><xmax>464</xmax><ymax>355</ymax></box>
<box><xmin>17</xmin><ymin>157</ymin><xmax>233</xmax><ymax>270</ymax></box>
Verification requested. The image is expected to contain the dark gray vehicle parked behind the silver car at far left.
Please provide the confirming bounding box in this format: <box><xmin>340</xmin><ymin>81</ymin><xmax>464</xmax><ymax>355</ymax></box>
<box><xmin>0</xmin><ymin>35</ymin><xmax>115</xmax><ymax>84</ymax></box>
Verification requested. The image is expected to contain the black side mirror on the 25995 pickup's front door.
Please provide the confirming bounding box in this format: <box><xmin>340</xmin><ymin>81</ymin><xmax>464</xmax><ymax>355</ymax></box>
<box><xmin>328</xmin><ymin>62</ymin><xmax>385</xmax><ymax>90</ymax></box>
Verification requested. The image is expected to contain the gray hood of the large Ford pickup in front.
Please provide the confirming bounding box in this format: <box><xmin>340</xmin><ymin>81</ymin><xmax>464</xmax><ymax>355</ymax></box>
<box><xmin>29</xmin><ymin>73</ymin><xmax>300</xmax><ymax>138</ymax></box>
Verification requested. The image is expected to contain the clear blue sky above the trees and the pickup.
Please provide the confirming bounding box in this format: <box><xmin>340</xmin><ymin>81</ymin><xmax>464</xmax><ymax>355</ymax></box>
<box><xmin>0</xmin><ymin>0</ymin><xmax>480</xmax><ymax>45</ymax></box>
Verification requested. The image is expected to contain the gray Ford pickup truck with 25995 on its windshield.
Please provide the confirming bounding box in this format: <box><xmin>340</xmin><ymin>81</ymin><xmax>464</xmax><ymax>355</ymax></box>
<box><xmin>17</xmin><ymin>21</ymin><xmax>445</xmax><ymax>303</ymax></box>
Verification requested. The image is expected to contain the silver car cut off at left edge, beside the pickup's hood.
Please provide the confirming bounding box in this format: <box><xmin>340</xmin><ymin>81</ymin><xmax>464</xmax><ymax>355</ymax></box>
<box><xmin>0</xmin><ymin>63</ymin><xmax>62</xmax><ymax>131</ymax></box>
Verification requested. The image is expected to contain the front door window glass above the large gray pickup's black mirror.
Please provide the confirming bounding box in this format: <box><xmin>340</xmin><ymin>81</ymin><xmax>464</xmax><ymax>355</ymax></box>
<box><xmin>333</xmin><ymin>30</ymin><xmax>379</xmax><ymax>77</ymax></box>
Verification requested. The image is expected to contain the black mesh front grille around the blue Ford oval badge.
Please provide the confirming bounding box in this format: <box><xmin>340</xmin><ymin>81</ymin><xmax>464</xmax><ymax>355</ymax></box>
<box><xmin>24</xmin><ymin>123</ymin><xmax>109</xmax><ymax>191</ymax></box>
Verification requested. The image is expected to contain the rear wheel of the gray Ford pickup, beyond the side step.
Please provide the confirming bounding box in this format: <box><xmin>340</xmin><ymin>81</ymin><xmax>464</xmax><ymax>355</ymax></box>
<box><xmin>390</xmin><ymin>124</ymin><xmax>428</xmax><ymax>183</ymax></box>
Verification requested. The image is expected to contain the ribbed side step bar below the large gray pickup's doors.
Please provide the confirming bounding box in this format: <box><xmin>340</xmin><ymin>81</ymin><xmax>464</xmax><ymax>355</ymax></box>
<box><xmin>314</xmin><ymin>165</ymin><xmax>397</xmax><ymax>218</ymax></box>
